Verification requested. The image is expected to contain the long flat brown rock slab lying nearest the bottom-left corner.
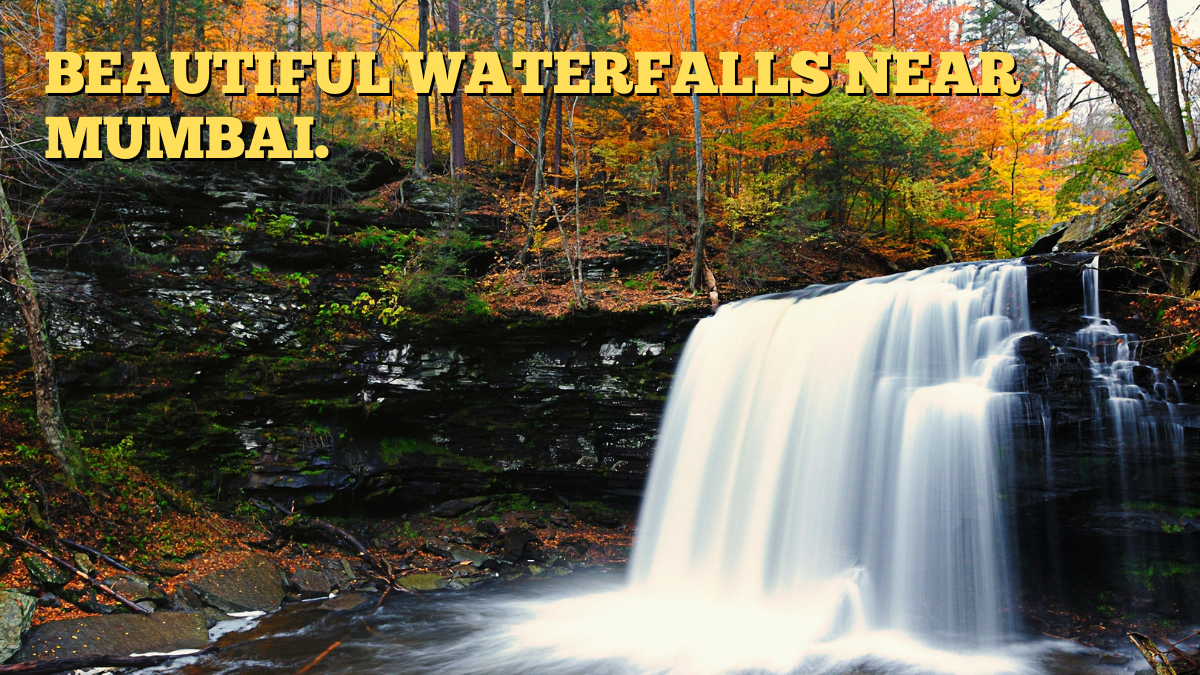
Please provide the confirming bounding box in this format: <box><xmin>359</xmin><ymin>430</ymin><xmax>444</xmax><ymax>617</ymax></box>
<box><xmin>16</xmin><ymin>613</ymin><xmax>209</xmax><ymax>662</ymax></box>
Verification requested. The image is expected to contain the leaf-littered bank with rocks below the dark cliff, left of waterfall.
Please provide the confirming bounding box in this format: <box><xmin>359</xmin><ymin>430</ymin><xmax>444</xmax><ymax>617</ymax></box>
<box><xmin>0</xmin><ymin>398</ymin><xmax>634</xmax><ymax>625</ymax></box>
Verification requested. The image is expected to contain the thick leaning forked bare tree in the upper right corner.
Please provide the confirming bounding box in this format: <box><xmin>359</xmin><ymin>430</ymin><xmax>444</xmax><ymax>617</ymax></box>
<box><xmin>996</xmin><ymin>0</ymin><xmax>1200</xmax><ymax>233</ymax></box>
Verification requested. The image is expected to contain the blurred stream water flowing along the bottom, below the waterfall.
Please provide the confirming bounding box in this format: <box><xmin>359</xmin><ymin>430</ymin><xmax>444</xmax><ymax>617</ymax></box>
<box><xmin>145</xmin><ymin>568</ymin><xmax>1144</xmax><ymax>675</ymax></box>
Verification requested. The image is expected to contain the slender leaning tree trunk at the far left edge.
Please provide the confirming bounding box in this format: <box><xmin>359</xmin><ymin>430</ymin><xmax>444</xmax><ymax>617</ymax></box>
<box><xmin>0</xmin><ymin>180</ymin><xmax>88</xmax><ymax>488</ymax></box>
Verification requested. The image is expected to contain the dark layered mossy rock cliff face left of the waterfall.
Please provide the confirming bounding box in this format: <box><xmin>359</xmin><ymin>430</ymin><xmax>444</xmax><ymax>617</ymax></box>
<box><xmin>0</xmin><ymin>162</ymin><xmax>702</xmax><ymax>513</ymax></box>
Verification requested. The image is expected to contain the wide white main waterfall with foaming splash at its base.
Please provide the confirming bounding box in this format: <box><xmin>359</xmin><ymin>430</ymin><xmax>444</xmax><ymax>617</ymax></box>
<box><xmin>512</xmin><ymin>262</ymin><xmax>1030</xmax><ymax>673</ymax></box>
